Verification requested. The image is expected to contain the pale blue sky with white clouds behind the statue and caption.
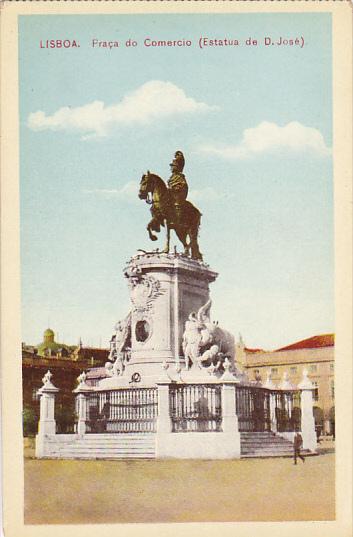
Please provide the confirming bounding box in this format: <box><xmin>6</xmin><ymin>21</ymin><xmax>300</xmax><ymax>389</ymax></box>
<box><xmin>19</xmin><ymin>14</ymin><xmax>334</xmax><ymax>349</ymax></box>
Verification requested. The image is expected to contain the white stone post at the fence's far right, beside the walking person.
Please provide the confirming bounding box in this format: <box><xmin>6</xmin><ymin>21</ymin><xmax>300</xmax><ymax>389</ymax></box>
<box><xmin>298</xmin><ymin>369</ymin><xmax>317</xmax><ymax>451</ymax></box>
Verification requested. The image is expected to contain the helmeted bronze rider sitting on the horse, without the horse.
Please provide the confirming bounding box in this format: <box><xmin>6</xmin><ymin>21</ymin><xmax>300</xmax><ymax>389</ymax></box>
<box><xmin>168</xmin><ymin>151</ymin><xmax>188</xmax><ymax>225</ymax></box>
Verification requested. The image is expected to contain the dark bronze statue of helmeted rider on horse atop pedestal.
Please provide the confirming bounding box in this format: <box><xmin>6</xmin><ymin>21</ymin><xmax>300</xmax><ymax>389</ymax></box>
<box><xmin>138</xmin><ymin>151</ymin><xmax>202</xmax><ymax>260</ymax></box>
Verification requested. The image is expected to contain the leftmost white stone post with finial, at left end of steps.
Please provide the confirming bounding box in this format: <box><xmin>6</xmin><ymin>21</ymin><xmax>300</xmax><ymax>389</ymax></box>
<box><xmin>36</xmin><ymin>371</ymin><xmax>59</xmax><ymax>457</ymax></box>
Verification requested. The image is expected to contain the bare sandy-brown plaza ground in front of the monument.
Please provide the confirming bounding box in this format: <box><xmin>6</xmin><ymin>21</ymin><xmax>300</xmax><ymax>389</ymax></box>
<box><xmin>24</xmin><ymin>445</ymin><xmax>335</xmax><ymax>524</ymax></box>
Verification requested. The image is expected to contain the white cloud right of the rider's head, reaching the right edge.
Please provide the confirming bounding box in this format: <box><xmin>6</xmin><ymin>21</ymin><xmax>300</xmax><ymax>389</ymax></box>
<box><xmin>199</xmin><ymin>121</ymin><xmax>331</xmax><ymax>160</ymax></box>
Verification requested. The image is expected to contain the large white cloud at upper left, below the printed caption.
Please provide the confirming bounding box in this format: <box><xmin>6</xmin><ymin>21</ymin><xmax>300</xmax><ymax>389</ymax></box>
<box><xmin>27</xmin><ymin>80</ymin><xmax>218</xmax><ymax>138</ymax></box>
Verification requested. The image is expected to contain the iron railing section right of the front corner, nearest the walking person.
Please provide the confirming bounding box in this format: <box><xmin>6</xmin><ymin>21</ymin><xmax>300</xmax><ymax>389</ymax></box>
<box><xmin>235</xmin><ymin>386</ymin><xmax>301</xmax><ymax>432</ymax></box>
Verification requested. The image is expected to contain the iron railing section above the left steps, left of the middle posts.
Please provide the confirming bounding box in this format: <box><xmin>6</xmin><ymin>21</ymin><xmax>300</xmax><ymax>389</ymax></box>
<box><xmin>86</xmin><ymin>388</ymin><xmax>158</xmax><ymax>433</ymax></box>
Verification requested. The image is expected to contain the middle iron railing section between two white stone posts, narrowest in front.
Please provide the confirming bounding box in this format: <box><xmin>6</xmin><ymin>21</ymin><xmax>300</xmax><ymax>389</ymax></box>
<box><xmin>169</xmin><ymin>384</ymin><xmax>222</xmax><ymax>433</ymax></box>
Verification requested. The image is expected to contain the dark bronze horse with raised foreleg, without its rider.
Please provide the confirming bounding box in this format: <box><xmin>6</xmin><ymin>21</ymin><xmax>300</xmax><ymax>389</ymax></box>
<box><xmin>138</xmin><ymin>172</ymin><xmax>202</xmax><ymax>260</ymax></box>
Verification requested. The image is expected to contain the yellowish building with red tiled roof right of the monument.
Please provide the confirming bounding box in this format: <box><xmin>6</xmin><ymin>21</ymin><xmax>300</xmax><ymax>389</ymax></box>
<box><xmin>236</xmin><ymin>334</ymin><xmax>335</xmax><ymax>435</ymax></box>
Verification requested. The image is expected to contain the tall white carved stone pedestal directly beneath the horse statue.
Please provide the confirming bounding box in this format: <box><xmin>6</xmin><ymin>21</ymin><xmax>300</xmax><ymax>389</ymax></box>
<box><xmin>120</xmin><ymin>253</ymin><xmax>217</xmax><ymax>383</ymax></box>
